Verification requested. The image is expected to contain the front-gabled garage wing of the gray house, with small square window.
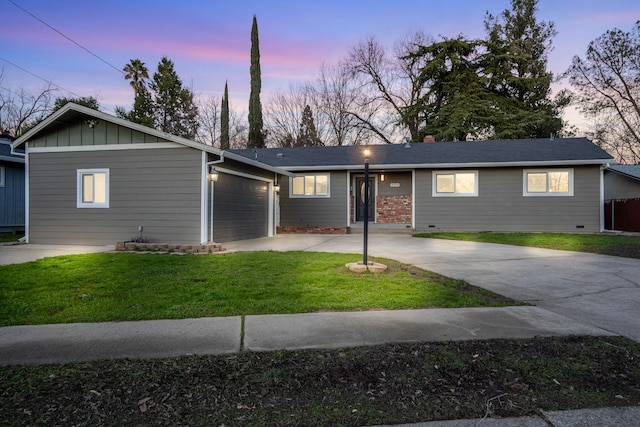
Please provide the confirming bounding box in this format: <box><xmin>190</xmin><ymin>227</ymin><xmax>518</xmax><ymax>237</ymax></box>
<box><xmin>14</xmin><ymin>103</ymin><xmax>286</xmax><ymax>245</ymax></box>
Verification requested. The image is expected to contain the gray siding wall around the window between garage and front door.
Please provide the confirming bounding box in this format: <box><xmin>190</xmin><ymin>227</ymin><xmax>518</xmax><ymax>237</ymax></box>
<box><xmin>280</xmin><ymin>172</ymin><xmax>349</xmax><ymax>227</ymax></box>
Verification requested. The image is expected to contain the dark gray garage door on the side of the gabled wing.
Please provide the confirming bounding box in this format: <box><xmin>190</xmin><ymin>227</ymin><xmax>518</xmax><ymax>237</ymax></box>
<box><xmin>213</xmin><ymin>174</ymin><xmax>269</xmax><ymax>242</ymax></box>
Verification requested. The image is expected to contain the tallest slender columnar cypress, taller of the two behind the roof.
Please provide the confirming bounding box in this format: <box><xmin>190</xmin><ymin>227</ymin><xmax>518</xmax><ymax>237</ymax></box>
<box><xmin>248</xmin><ymin>15</ymin><xmax>265</xmax><ymax>148</ymax></box>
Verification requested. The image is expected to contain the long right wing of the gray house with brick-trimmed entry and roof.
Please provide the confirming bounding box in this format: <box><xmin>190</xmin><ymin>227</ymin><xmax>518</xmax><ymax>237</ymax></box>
<box><xmin>232</xmin><ymin>138</ymin><xmax>613</xmax><ymax>233</ymax></box>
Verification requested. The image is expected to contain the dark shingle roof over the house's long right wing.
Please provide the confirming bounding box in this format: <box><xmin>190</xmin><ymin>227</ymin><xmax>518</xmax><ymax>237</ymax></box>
<box><xmin>230</xmin><ymin>138</ymin><xmax>613</xmax><ymax>170</ymax></box>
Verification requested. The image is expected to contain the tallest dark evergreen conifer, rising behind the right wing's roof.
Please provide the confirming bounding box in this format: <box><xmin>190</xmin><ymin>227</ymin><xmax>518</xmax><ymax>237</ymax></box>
<box><xmin>479</xmin><ymin>0</ymin><xmax>566</xmax><ymax>139</ymax></box>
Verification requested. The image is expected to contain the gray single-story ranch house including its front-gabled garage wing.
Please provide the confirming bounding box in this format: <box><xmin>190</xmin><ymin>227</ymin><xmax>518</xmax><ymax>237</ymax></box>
<box><xmin>14</xmin><ymin>104</ymin><xmax>613</xmax><ymax>244</ymax></box>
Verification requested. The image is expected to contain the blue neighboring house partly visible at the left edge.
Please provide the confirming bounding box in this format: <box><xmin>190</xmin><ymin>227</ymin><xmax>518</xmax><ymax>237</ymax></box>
<box><xmin>0</xmin><ymin>135</ymin><xmax>25</xmax><ymax>233</ymax></box>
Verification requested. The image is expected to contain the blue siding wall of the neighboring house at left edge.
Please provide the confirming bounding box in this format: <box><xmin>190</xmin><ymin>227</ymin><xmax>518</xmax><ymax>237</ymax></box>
<box><xmin>0</xmin><ymin>161</ymin><xmax>25</xmax><ymax>229</ymax></box>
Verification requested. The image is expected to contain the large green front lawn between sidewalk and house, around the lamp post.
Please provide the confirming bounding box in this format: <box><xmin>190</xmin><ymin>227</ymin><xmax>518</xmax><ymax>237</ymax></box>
<box><xmin>0</xmin><ymin>252</ymin><xmax>513</xmax><ymax>326</ymax></box>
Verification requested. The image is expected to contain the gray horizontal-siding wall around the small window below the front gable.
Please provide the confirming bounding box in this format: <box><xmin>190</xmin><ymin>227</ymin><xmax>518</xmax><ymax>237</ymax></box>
<box><xmin>29</xmin><ymin>147</ymin><xmax>202</xmax><ymax>245</ymax></box>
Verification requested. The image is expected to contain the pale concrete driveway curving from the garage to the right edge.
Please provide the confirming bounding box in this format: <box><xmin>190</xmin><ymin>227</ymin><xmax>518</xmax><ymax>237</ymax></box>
<box><xmin>224</xmin><ymin>234</ymin><xmax>640</xmax><ymax>341</ymax></box>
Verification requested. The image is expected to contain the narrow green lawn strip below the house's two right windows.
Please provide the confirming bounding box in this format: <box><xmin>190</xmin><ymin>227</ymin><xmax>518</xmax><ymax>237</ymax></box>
<box><xmin>415</xmin><ymin>232</ymin><xmax>640</xmax><ymax>258</ymax></box>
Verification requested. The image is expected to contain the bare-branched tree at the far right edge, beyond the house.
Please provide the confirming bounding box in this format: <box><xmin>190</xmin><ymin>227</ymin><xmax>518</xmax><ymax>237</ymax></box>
<box><xmin>565</xmin><ymin>21</ymin><xmax>640</xmax><ymax>164</ymax></box>
